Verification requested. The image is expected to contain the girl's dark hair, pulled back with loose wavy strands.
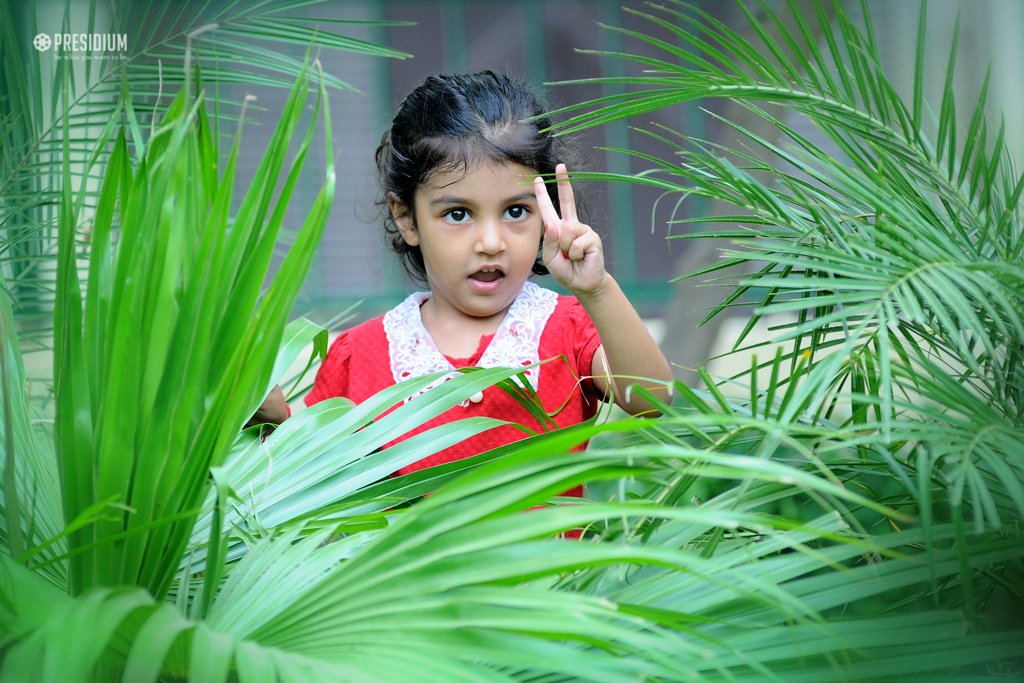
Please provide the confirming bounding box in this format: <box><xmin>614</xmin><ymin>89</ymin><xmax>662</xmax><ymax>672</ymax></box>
<box><xmin>377</xmin><ymin>71</ymin><xmax>564</xmax><ymax>282</ymax></box>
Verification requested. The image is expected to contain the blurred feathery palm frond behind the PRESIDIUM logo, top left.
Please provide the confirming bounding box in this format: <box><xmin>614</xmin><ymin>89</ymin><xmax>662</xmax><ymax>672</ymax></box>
<box><xmin>0</xmin><ymin>0</ymin><xmax>410</xmax><ymax>348</ymax></box>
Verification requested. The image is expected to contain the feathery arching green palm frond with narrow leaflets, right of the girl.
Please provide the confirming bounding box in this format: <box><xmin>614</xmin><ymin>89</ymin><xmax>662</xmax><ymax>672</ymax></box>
<box><xmin>557</xmin><ymin>3</ymin><xmax>1024</xmax><ymax>529</ymax></box>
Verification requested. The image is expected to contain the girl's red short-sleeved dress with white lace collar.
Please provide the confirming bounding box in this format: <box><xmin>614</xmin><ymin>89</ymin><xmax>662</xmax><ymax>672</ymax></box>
<box><xmin>305</xmin><ymin>283</ymin><xmax>601</xmax><ymax>485</ymax></box>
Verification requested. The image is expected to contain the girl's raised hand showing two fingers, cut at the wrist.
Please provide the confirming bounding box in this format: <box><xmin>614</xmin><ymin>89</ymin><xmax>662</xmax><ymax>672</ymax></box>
<box><xmin>534</xmin><ymin>164</ymin><xmax>607</xmax><ymax>294</ymax></box>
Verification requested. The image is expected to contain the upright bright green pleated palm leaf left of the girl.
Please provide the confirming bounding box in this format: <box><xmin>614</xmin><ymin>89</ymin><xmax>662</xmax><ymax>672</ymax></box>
<box><xmin>44</xmin><ymin>54</ymin><xmax>334</xmax><ymax>597</ymax></box>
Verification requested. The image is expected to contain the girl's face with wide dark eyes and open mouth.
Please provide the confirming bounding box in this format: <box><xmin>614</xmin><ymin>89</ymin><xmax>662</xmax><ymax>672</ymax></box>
<box><xmin>391</xmin><ymin>161</ymin><xmax>543</xmax><ymax>319</ymax></box>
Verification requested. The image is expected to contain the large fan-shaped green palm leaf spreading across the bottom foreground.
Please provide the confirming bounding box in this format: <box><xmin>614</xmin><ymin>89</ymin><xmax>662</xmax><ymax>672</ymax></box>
<box><xmin>4</xmin><ymin>422</ymin><xmax>1024</xmax><ymax>681</ymax></box>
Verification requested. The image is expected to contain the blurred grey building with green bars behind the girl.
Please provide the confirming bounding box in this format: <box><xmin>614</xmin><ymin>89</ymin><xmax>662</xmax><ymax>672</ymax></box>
<box><xmin>200</xmin><ymin>0</ymin><xmax>1024</xmax><ymax>374</ymax></box>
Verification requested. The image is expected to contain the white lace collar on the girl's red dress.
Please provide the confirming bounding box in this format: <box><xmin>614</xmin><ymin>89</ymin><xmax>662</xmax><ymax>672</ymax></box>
<box><xmin>384</xmin><ymin>282</ymin><xmax>558</xmax><ymax>408</ymax></box>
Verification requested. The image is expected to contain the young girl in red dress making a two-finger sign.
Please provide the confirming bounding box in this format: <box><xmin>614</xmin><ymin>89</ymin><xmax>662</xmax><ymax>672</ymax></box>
<box><xmin>256</xmin><ymin>72</ymin><xmax>672</xmax><ymax>483</ymax></box>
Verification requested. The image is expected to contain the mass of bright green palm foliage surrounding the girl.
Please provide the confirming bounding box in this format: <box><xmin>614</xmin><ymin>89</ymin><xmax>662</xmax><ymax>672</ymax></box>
<box><xmin>0</xmin><ymin>0</ymin><xmax>1024</xmax><ymax>682</ymax></box>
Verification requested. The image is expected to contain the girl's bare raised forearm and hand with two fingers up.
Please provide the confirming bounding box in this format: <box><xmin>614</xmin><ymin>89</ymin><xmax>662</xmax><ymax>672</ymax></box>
<box><xmin>534</xmin><ymin>164</ymin><xmax>672</xmax><ymax>415</ymax></box>
